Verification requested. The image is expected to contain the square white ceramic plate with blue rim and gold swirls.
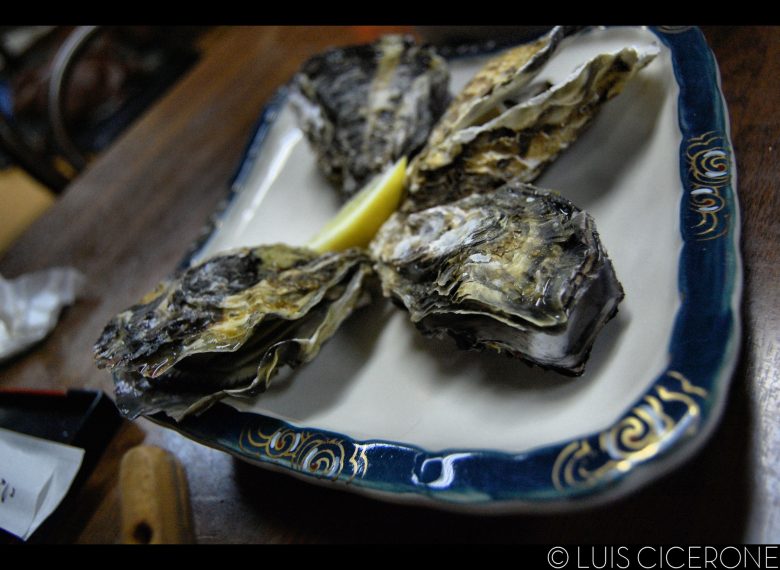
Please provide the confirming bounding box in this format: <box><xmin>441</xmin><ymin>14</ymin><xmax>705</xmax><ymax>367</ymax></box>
<box><xmin>149</xmin><ymin>28</ymin><xmax>741</xmax><ymax>512</ymax></box>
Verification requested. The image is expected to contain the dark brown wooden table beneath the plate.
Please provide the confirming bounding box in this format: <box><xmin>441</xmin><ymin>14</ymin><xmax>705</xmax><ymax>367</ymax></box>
<box><xmin>0</xmin><ymin>27</ymin><xmax>780</xmax><ymax>543</ymax></box>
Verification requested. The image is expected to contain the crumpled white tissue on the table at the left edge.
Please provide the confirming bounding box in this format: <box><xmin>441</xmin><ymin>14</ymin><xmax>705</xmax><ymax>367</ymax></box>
<box><xmin>0</xmin><ymin>267</ymin><xmax>86</xmax><ymax>362</ymax></box>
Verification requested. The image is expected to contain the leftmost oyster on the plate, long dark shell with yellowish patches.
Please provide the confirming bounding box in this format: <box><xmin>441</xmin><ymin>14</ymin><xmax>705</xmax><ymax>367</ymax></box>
<box><xmin>94</xmin><ymin>244</ymin><xmax>371</xmax><ymax>419</ymax></box>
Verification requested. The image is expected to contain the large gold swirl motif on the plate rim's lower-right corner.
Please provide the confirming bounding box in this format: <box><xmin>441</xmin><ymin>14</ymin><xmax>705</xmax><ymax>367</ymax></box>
<box><xmin>552</xmin><ymin>370</ymin><xmax>707</xmax><ymax>491</ymax></box>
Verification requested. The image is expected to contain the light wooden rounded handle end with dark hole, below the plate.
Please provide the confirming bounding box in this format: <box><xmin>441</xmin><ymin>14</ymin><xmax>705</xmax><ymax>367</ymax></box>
<box><xmin>119</xmin><ymin>445</ymin><xmax>195</xmax><ymax>544</ymax></box>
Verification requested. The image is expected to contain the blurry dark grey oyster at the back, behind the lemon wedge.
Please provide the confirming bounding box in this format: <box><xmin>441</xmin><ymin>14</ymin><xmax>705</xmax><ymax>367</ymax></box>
<box><xmin>290</xmin><ymin>35</ymin><xmax>450</xmax><ymax>198</ymax></box>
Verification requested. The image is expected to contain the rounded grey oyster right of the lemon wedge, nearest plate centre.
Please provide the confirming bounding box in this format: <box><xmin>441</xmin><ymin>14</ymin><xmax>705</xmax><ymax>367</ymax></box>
<box><xmin>370</xmin><ymin>183</ymin><xmax>623</xmax><ymax>375</ymax></box>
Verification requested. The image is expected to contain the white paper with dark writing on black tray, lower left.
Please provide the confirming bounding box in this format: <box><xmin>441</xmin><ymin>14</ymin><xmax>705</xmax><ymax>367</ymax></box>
<box><xmin>0</xmin><ymin>428</ymin><xmax>84</xmax><ymax>540</ymax></box>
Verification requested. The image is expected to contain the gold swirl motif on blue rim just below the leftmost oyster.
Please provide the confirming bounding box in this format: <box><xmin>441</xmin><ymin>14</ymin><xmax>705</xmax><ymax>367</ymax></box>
<box><xmin>239</xmin><ymin>426</ymin><xmax>368</xmax><ymax>481</ymax></box>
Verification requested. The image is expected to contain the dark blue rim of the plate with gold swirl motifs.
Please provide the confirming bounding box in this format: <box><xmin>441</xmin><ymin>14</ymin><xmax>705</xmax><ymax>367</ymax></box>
<box><xmin>149</xmin><ymin>26</ymin><xmax>742</xmax><ymax>512</ymax></box>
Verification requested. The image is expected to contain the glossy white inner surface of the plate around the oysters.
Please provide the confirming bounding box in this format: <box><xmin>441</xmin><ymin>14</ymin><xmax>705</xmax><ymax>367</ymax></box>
<box><xmin>199</xmin><ymin>28</ymin><xmax>682</xmax><ymax>453</ymax></box>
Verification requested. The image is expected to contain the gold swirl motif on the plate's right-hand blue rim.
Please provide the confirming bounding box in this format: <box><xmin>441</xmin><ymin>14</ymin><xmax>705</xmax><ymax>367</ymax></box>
<box><xmin>685</xmin><ymin>131</ymin><xmax>731</xmax><ymax>241</ymax></box>
